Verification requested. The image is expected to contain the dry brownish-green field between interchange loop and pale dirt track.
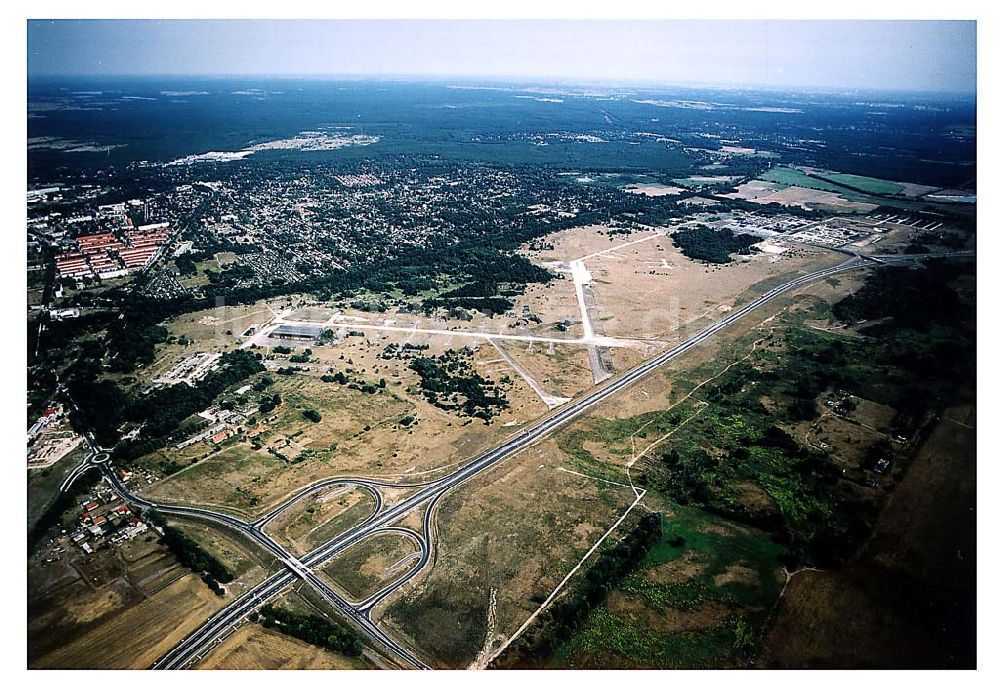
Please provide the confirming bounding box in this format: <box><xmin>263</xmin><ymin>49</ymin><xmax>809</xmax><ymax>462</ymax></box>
<box><xmin>376</xmin><ymin>441</ymin><xmax>635</xmax><ymax>668</ymax></box>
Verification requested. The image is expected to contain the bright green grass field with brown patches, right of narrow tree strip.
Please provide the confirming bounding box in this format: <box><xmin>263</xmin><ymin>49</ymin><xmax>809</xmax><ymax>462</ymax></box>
<box><xmin>545</xmin><ymin>505</ymin><xmax>783</xmax><ymax>669</ymax></box>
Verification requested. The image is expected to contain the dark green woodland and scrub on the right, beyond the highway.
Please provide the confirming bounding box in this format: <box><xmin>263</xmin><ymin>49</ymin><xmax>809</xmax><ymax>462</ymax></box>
<box><xmin>637</xmin><ymin>262</ymin><xmax>975</xmax><ymax>567</ymax></box>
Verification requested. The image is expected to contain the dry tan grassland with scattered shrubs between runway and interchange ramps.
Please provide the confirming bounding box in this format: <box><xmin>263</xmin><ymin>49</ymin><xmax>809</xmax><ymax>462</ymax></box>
<box><xmin>139</xmin><ymin>346</ymin><xmax>547</xmax><ymax>516</ymax></box>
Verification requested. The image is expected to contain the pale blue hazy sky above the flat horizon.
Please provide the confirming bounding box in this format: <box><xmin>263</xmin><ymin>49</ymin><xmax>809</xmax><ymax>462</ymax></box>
<box><xmin>28</xmin><ymin>20</ymin><xmax>976</xmax><ymax>93</ymax></box>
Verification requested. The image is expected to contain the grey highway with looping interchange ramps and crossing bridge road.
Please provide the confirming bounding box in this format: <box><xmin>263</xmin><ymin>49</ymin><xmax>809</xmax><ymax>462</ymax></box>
<box><xmin>63</xmin><ymin>252</ymin><xmax>972</xmax><ymax>669</ymax></box>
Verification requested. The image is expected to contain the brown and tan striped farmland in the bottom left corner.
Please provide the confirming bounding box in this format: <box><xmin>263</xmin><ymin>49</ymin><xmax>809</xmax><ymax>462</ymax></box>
<box><xmin>28</xmin><ymin>506</ymin><xmax>273</xmax><ymax>668</ymax></box>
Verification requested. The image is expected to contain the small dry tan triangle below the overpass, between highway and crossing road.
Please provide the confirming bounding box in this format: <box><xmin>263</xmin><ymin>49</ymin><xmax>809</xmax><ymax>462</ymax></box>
<box><xmin>193</xmin><ymin>623</ymin><xmax>372</xmax><ymax>671</ymax></box>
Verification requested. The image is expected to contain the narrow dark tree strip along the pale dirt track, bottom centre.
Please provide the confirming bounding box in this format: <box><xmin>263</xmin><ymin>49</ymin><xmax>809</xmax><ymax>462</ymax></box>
<box><xmin>491</xmin><ymin>513</ymin><xmax>662</xmax><ymax>668</ymax></box>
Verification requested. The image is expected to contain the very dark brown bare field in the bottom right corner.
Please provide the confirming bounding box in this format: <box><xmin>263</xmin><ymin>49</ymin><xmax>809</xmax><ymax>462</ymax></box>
<box><xmin>762</xmin><ymin>405</ymin><xmax>976</xmax><ymax>668</ymax></box>
